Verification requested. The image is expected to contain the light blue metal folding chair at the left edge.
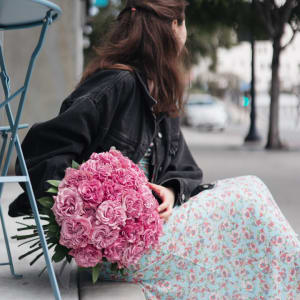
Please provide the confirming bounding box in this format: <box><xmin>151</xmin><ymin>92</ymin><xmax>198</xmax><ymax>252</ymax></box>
<box><xmin>0</xmin><ymin>0</ymin><xmax>61</xmax><ymax>299</ymax></box>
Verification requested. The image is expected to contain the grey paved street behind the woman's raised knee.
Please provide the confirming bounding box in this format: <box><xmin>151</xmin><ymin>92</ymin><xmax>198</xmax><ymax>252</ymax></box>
<box><xmin>182</xmin><ymin>115</ymin><xmax>300</xmax><ymax>234</ymax></box>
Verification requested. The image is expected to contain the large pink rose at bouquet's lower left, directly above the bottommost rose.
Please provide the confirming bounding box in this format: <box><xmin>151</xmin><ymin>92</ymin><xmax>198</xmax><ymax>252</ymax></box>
<box><xmin>59</xmin><ymin>216</ymin><xmax>92</xmax><ymax>249</ymax></box>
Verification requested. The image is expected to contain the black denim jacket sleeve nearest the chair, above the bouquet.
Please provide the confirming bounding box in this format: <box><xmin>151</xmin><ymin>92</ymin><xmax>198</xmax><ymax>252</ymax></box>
<box><xmin>15</xmin><ymin>73</ymin><xmax>132</xmax><ymax>198</ymax></box>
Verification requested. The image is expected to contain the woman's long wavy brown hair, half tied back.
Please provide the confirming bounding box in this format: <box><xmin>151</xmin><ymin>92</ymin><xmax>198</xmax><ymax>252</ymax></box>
<box><xmin>79</xmin><ymin>0</ymin><xmax>188</xmax><ymax>116</ymax></box>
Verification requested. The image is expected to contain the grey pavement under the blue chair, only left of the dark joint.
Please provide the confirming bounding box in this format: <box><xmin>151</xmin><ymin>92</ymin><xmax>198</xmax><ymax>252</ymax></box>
<box><xmin>0</xmin><ymin>183</ymin><xmax>78</xmax><ymax>300</ymax></box>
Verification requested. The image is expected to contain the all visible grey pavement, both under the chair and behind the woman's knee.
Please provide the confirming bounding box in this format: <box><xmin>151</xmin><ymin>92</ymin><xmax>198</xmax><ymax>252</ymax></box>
<box><xmin>0</xmin><ymin>123</ymin><xmax>300</xmax><ymax>300</ymax></box>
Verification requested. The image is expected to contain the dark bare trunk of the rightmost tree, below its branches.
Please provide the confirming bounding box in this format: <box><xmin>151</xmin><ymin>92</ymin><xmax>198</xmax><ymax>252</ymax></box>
<box><xmin>265</xmin><ymin>36</ymin><xmax>283</xmax><ymax>149</ymax></box>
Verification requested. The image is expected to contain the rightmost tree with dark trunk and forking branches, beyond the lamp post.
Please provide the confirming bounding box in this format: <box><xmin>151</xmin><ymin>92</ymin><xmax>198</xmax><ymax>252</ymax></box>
<box><xmin>253</xmin><ymin>0</ymin><xmax>300</xmax><ymax>149</ymax></box>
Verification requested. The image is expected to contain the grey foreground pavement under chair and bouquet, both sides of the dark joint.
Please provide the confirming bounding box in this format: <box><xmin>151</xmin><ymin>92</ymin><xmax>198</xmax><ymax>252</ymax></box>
<box><xmin>0</xmin><ymin>184</ymin><xmax>145</xmax><ymax>300</ymax></box>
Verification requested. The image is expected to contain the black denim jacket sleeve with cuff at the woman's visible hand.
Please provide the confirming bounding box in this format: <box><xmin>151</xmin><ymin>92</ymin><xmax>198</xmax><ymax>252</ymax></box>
<box><xmin>158</xmin><ymin>130</ymin><xmax>203</xmax><ymax>206</ymax></box>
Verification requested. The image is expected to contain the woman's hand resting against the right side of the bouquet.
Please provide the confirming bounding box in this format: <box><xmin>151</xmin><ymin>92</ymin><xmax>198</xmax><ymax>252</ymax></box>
<box><xmin>149</xmin><ymin>182</ymin><xmax>175</xmax><ymax>222</ymax></box>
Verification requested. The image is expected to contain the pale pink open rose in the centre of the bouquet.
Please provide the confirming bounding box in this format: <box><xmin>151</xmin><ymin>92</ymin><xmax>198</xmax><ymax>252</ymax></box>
<box><xmin>96</xmin><ymin>200</ymin><xmax>126</xmax><ymax>229</ymax></box>
